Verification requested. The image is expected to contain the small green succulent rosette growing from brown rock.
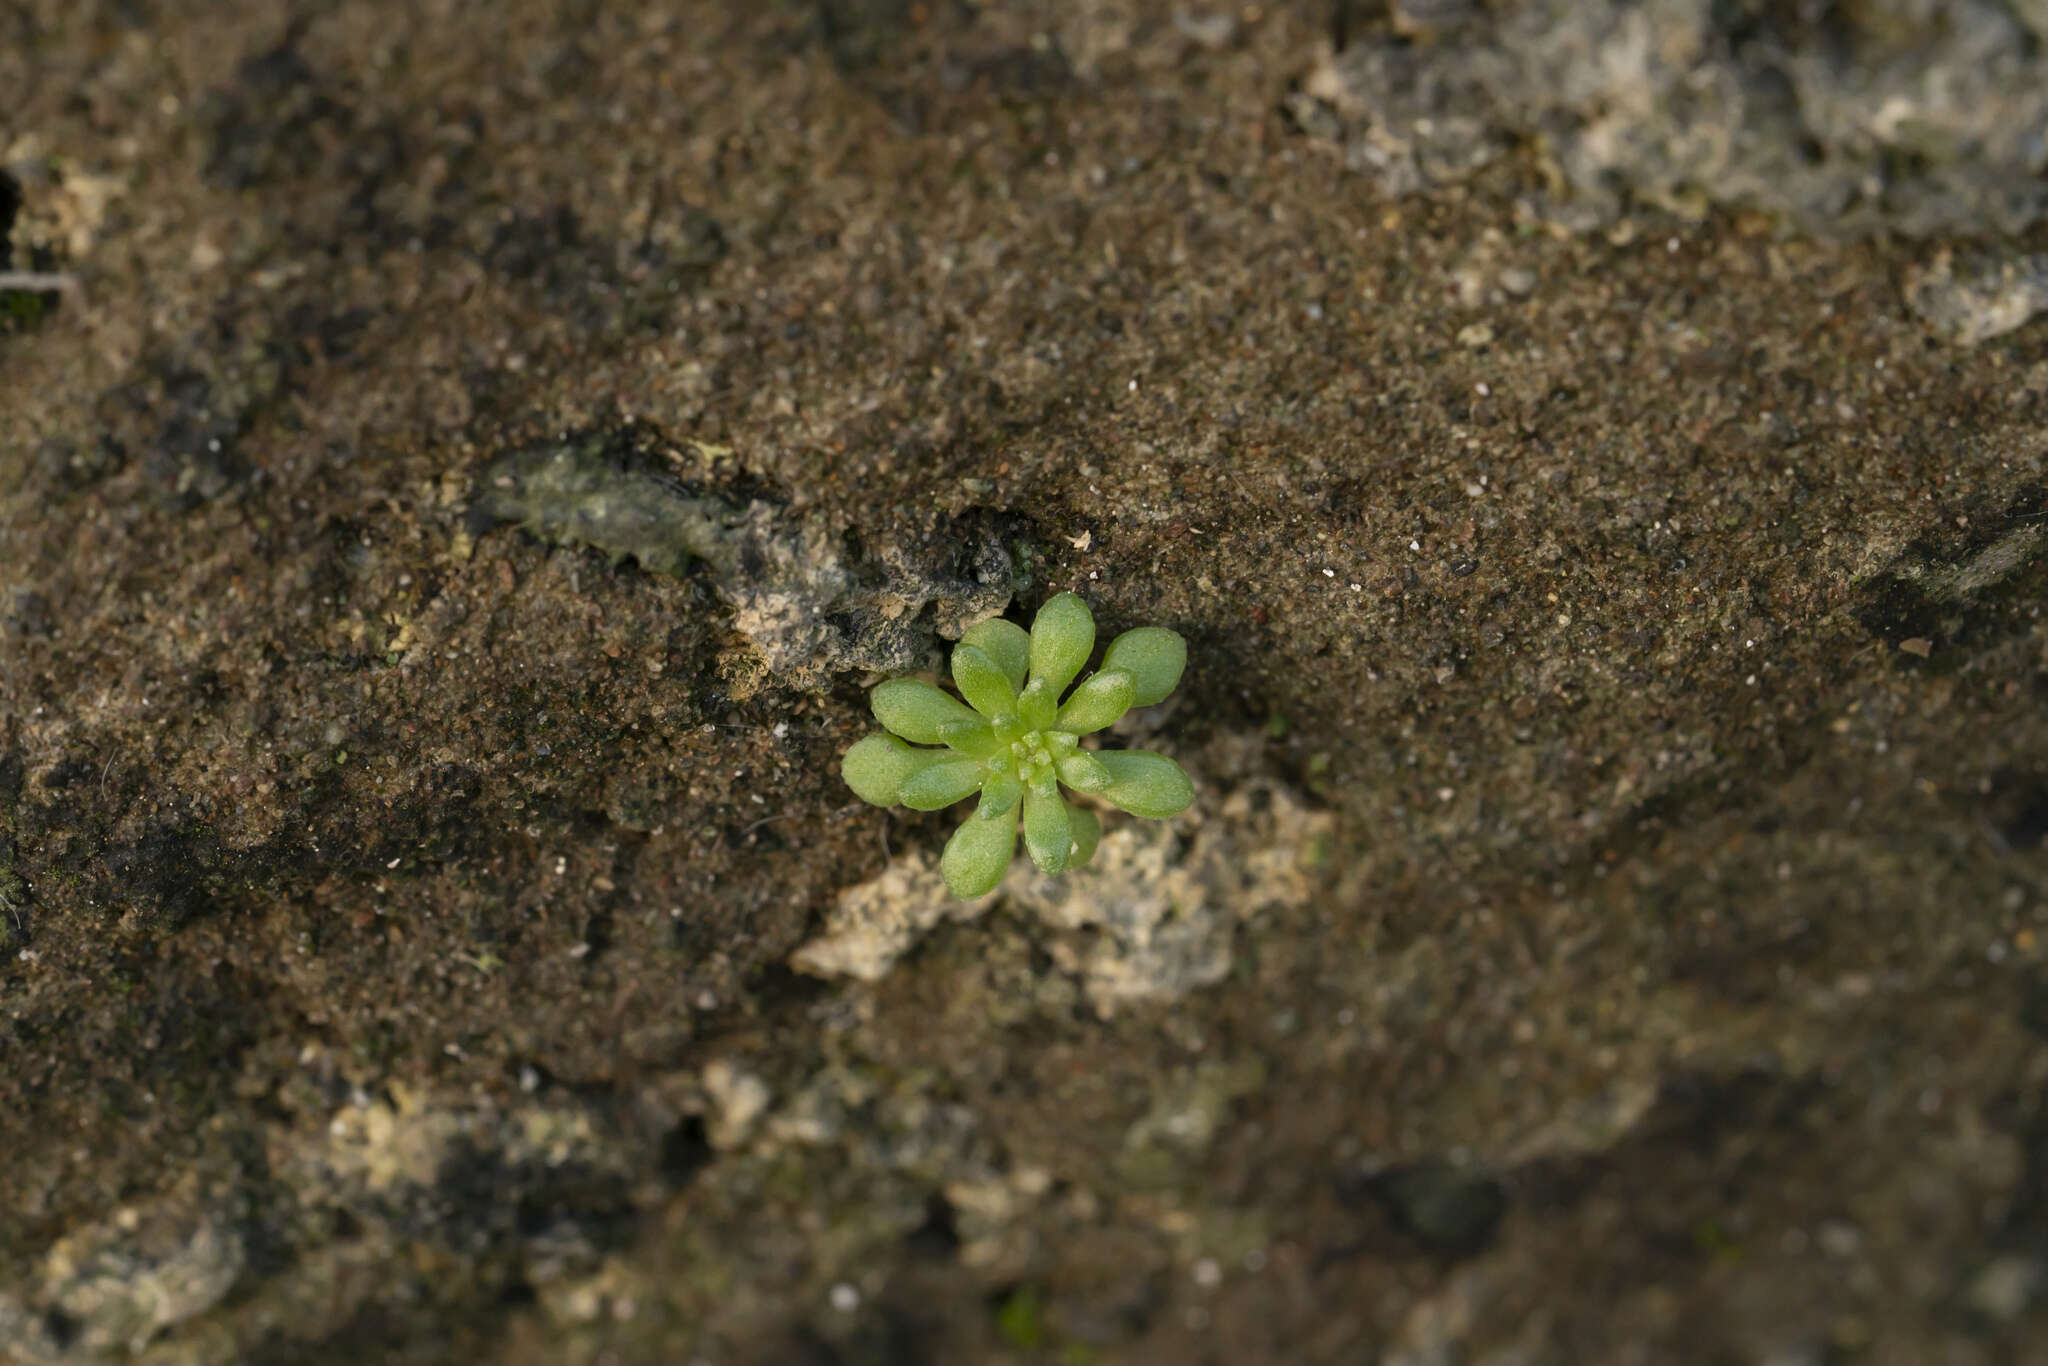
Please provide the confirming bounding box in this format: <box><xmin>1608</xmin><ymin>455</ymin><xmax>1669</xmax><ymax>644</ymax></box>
<box><xmin>840</xmin><ymin>592</ymin><xmax>1194</xmax><ymax>897</ymax></box>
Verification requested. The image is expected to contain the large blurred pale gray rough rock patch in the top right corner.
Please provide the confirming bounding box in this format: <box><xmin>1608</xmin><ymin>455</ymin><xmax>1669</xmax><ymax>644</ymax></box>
<box><xmin>1292</xmin><ymin>0</ymin><xmax>2048</xmax><ymax>236</ymax></box>
